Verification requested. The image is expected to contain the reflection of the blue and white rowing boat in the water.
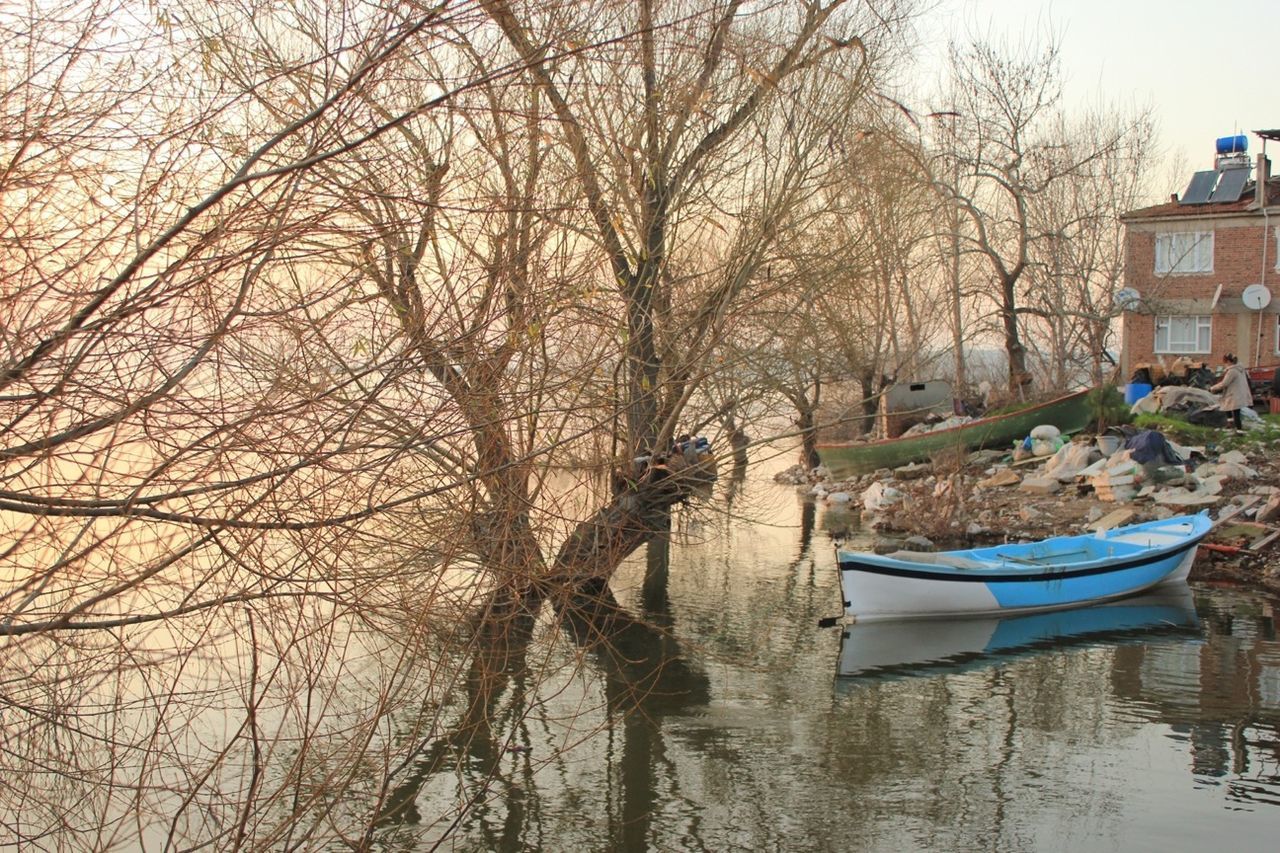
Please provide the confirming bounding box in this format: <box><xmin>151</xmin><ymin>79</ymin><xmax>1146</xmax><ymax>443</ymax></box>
<box><xmin>837</xmin><ymin>584</ymin><xmax>1199</xmax><ymax>686</ymax></box>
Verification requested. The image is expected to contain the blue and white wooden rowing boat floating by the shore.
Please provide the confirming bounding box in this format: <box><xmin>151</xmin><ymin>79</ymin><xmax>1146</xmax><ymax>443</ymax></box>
<box><xmin>836</xmin><ymin>515</ymin><xmax>1211</xmax><ymax>621</ymax></box>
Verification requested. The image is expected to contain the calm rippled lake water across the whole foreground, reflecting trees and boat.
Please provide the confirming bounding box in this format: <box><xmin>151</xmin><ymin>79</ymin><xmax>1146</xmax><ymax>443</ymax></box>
<box><xmin>0</xmin><ymin>459</ymin><xmax>1280</xmax><ymax>853</ymax></box>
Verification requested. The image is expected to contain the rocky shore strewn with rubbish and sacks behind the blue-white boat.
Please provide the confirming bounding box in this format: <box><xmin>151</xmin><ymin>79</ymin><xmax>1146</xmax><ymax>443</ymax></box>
<box><xmin>777</xmin><ymin>437</ymin><xmax>1280</xmax><ymax>594</ymax></box>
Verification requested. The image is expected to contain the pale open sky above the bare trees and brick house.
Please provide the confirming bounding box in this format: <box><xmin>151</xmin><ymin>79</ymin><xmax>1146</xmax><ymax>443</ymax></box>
<box><xmin>923</xmin><ymin>0</ymin><xmax>1280</xmax><ymax>178</ymax></box>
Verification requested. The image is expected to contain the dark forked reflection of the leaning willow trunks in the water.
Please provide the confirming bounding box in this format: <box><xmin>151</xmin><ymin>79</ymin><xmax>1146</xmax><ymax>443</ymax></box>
<box><xmin>379</xmin><ymin>535</ymin><xmax>710</xmax><ymax>850</ymax></box>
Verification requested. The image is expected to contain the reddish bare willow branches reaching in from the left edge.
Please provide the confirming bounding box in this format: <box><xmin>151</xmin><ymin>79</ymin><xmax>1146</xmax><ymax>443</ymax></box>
<box><xmin>0</xmin><ymin>3</ymin><xmax>578</xmax><ymax>849</ymax></box>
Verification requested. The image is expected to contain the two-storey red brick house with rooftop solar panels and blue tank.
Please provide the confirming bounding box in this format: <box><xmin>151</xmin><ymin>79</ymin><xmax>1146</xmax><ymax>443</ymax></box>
<box><xmin>1120</xmin><ymin>131</ymin><xmax>1280</xmax><ymax>378</ymax></box>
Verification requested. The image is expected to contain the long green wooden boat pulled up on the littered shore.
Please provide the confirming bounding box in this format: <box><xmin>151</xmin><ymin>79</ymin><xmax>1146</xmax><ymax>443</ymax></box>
<box><xmin>818</xmin><ymin>388</ymin><xmax>1092</xmax><ymax>476</ymax></box>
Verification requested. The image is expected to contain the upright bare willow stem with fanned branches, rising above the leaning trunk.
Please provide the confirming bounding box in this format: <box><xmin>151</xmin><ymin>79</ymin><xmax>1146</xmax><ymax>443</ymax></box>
<box><xmin>483</xmin><ymin>0</ymin><xmax>900</xmax><ymax>455</ymax></box>
